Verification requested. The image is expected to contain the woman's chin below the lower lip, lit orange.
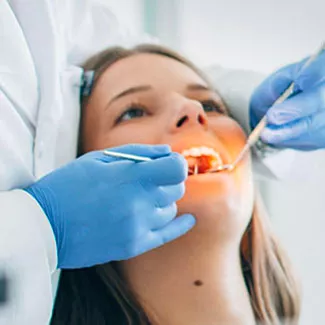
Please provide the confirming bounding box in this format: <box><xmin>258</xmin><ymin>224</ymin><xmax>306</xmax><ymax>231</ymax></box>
<box><xmin>177</xmin><ymin>167</ymin><xmax>254</xmax><ymax>241</ymax></box>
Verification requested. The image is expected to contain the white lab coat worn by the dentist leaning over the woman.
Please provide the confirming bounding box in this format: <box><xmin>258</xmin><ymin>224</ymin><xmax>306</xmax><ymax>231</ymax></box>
<box><xmin>0</xmin><ymin>0</ymin><xmax>296</xmax><ymax>325</ymax></box>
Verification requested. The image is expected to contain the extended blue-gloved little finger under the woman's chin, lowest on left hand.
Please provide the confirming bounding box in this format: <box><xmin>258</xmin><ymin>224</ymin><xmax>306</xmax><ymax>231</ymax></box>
<box><xmin>123</xmin><ymin>214</ymin><xmax>196</xmax><ymax>258</ymax></box>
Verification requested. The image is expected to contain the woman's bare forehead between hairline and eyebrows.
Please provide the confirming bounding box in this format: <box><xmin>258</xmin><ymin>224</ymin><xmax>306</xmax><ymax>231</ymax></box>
<box><xmin>96</xmin><ymin>53</ymin><xmax>207</xmax><ymax>98</ymax></box>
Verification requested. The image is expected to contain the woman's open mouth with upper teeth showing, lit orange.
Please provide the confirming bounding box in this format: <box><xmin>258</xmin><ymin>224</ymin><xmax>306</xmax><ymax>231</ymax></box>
<box><xmin>182</xmin><ymin>146</ymin><xmax>223</xmax><ymax>175</ymax></box>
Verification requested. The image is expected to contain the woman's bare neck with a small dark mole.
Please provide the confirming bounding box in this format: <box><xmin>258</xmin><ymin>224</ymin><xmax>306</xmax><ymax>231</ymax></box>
<box><xmin>123</xmin><ymin>236</ymin><xmax>255</xmax><ymax>325</ymax></box>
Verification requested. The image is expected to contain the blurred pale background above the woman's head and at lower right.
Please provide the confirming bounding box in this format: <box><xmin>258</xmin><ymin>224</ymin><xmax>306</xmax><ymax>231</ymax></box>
<box><xmin>102</xmin><ymin>0</ymin><xmax>325</xmax><ymax>325</ymax></box>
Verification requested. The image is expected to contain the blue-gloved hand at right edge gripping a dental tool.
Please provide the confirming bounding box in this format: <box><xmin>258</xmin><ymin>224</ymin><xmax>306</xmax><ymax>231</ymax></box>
<box><xmin>250</xmin><ymin>53</ymin><xmax>325</xmax><ymax>150</ymax></box>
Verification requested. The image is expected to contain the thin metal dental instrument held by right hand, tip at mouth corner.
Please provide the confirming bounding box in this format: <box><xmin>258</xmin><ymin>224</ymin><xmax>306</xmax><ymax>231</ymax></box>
<box><xmin>207</xmin><ymin>42</ymin><xmax>325</xmax><ymax>173</ymax></box>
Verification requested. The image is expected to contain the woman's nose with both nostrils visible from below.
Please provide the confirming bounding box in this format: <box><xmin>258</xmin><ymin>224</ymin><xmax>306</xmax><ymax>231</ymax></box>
<box><xmin>173</xmin><ymin>99</ymin><xmax>208</xmax><ymax>131</ymax></box>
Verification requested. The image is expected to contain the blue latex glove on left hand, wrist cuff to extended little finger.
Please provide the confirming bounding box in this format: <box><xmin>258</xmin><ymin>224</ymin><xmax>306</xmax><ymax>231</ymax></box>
<box><xmin>26</xmin><ymin>145</ymin><xmax>195</xmax><ymax>268</ymax></box>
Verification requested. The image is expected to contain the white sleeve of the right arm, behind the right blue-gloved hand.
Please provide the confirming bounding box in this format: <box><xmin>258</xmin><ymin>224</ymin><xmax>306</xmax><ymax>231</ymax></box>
<box><xmin>205</xmin><ymin>66</ymin><xmax>302</xmax><ymax>179</ymax></box>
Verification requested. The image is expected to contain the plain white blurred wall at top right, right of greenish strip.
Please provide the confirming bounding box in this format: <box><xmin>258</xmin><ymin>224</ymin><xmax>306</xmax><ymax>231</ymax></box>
<box><xmin>178</xmin><ymin>0</ymin><xmax>325</xmax><ymax>72</ymax></box>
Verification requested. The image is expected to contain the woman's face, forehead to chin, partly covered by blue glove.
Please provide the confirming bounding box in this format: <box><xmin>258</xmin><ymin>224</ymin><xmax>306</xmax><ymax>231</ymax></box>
<box><xmin>82</xmin><ymin>53</ymin><xmax>253</xmax><ymax>238</ymax></box>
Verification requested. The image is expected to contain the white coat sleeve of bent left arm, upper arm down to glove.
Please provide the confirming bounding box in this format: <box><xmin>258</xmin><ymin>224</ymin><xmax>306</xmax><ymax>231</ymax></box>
<box><xmin>0</xmin><ymin>1</ymin><xmax>57</xmax><ymax>325</ymax></box>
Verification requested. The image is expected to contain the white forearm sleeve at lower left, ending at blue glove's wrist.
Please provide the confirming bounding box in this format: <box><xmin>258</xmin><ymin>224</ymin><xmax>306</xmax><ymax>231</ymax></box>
<box><xmin>0</xmin><ymin>190</ymin><xmax>57</xmax><ymax>325</ymax></box>
